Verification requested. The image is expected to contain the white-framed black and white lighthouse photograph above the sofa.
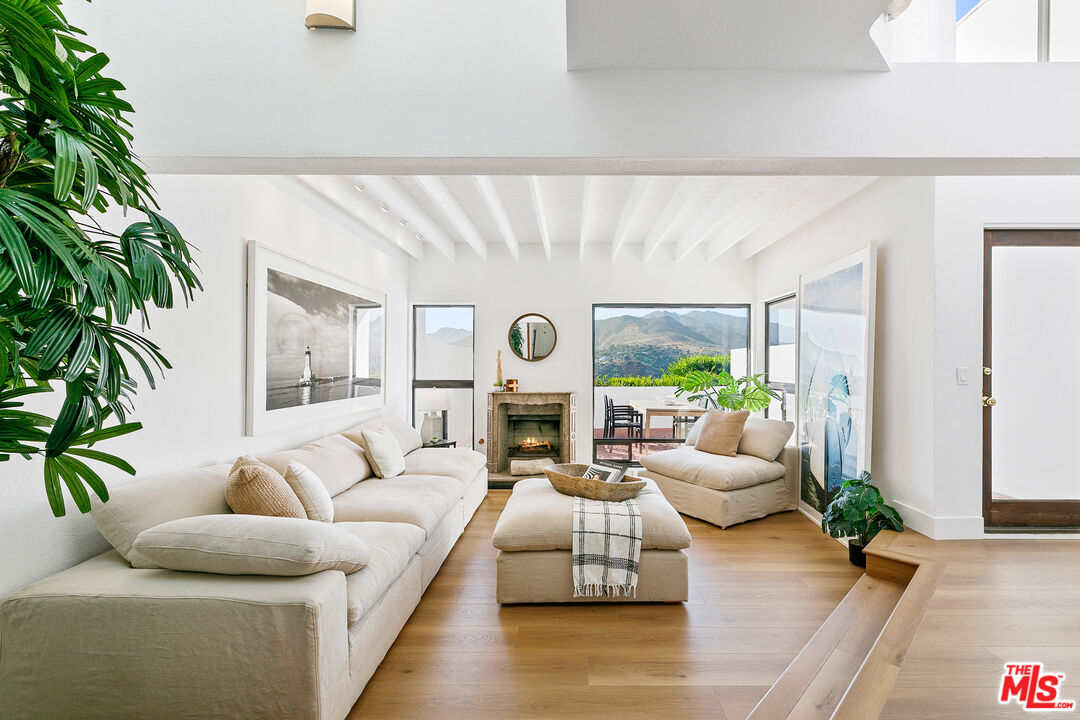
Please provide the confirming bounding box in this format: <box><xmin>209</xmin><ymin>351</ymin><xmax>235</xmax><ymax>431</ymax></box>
<box><xmin>247</xmin><ymin>242</ymin><xmax>386</xmax><ymax>435</ymax></box>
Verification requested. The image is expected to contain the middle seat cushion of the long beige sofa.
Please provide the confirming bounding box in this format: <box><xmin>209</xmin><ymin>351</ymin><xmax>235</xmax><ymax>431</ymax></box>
<box><xmin>334</xmin><ymin>475</ymin><xmax>463</xmax><ymax>535</ymax></box>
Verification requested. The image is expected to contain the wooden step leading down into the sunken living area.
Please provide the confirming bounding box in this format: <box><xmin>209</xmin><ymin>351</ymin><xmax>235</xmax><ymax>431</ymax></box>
<box><xmin>748</xmin><ymin>532</ymin><xmax>942</xmax><ymax>720</ymax></box>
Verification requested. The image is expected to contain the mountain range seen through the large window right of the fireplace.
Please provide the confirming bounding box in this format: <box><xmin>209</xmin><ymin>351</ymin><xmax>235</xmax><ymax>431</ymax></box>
<box><xmin>593</xmin><ymin>310</ymin><xmax>747</xmax><ymax>378</ymax></box>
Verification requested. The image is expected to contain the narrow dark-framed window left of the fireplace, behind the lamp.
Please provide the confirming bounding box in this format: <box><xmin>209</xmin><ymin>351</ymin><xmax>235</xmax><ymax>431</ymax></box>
<box><xmin>413</xmin><ymin>305</ymin><xmax>475</xmax><ymax>449</ymax></box>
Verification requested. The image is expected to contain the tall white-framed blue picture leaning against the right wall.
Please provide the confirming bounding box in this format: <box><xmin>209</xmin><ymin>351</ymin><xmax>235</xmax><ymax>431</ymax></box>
<box><xmin>796</xmin><ymin>244</ymin><xmax>877</xmax><ymax>514</ymax></box>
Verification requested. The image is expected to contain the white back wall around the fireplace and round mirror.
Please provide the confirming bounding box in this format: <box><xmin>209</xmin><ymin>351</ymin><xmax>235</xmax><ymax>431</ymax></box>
<box><xmin>409</xmin><ymin>243</ymin><xmax>757</xmax><ymax>461</ymax></box>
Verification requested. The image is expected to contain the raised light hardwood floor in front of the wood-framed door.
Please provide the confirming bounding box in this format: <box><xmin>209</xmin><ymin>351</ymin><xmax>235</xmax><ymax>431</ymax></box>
<box><xmin>881</xmin><ymin>532</ymin><xmax>1080</xmax><ymax>720</ymax></box>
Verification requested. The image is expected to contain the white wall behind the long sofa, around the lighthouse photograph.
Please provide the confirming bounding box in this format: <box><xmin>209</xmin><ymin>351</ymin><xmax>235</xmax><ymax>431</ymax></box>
<box><xmin>0</xmin><ymin>176</ymin><xmax>408</xmax><ymax>596</ymax></box>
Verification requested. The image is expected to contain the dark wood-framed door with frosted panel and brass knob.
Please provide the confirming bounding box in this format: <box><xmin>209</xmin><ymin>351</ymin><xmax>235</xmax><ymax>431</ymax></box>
<box><xmin>983</xmin><ymin>230</ymin><xmax>1080</xmax><ymax>527</ymax></box>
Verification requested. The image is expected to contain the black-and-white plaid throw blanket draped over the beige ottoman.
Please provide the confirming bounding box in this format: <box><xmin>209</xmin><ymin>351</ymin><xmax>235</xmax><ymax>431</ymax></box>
<box><xmin>571</xmin><ymin>498</ymin><xmax>642</xmax><ymax>598</ymax></box>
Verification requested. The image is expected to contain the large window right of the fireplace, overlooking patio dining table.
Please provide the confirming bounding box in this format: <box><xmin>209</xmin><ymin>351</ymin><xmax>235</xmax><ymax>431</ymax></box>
<box><xmin>593</xmin><ymin>304</ymin><xmax>750</xmax><ymax>463</ymax></box>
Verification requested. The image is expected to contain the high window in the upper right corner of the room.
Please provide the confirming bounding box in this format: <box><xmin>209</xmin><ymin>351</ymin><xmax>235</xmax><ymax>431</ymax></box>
<box><xmin>956</xmin><ymin>0</ymin><xmax>1080</xmax><ymax>63</ymax></box>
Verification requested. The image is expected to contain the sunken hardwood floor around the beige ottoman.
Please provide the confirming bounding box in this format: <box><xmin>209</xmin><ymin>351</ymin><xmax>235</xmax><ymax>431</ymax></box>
<box><xmin>349</xmin><ymin>490</ymin><xmax>862</xmax><ymax>720</ymax></box>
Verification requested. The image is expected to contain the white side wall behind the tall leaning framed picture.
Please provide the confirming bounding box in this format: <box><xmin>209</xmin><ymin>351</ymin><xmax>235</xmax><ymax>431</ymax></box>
<box><xmin>754</xmin><ymin>178</ymin><xmax>934</xmax><ymax>532</ymax></box>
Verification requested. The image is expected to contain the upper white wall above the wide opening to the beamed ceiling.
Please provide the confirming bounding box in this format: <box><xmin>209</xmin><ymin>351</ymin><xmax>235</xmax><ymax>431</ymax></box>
<box><xmin>65</xmin><ymin>0</ymin><xmax>1080</xmax><ymax>174</ymax></box>
